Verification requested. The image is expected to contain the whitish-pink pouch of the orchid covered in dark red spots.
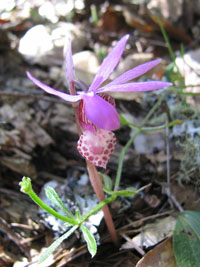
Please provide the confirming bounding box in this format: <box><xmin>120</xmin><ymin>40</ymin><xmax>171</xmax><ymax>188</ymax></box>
<box><xmin>77</xmin><ymin>129</ymin><xmax>117</xmax><ymax>168</ymax></box>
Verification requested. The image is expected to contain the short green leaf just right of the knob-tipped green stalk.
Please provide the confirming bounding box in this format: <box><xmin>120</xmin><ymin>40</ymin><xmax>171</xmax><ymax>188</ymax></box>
<box><xmin>45</xmin><ymin>186</ymin><xmax>75</xmax><ymax>219</ymax></box>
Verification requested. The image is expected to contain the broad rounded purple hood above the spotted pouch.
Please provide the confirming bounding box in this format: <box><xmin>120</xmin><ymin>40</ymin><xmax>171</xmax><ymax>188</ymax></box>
<box><xmin>82</xmin><ymin>94</ymin><xmax>120</xmax><ymax>131</ymax></box>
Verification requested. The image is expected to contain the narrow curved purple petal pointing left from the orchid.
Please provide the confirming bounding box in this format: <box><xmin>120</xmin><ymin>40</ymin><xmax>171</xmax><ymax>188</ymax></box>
<box><xmin>26</xmin><ymin>71</ymin><xmax>81</xmax><ymax>102</ymax></box>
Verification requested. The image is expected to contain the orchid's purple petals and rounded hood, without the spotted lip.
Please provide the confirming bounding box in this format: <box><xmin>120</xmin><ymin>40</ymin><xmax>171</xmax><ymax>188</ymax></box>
<box><xmin>27</xmin><ymin>35</ymin><xmax>171</xmax><ymax>131</ymax></box>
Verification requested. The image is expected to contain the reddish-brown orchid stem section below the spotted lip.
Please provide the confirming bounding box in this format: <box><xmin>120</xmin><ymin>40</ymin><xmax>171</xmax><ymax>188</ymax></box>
<box><xmin>87</xmin><ymin>161</ymin><xmax>118</xmax><ymax>245</ymax></box>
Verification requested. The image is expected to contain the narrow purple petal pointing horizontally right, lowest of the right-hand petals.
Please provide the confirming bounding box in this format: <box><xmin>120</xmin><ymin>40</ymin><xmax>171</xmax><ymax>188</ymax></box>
<box><xmin>98</xmin><ymin>81</ymin><xmax>172</xmax><ymax>93</ymax></box>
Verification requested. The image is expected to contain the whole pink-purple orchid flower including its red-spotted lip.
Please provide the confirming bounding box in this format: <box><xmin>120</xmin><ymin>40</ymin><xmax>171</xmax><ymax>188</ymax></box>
<box><xmin>27</xmin><ymin>35</ymin><xmax>172</xmax><ymax>168</ymax></box>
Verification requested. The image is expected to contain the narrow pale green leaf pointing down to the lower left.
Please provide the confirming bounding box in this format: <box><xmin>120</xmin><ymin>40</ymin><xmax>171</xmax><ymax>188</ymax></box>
<box><xmin>39</xmin><ymin>225</ymin><xmax>78</xmax><ymax>264</ymax></box>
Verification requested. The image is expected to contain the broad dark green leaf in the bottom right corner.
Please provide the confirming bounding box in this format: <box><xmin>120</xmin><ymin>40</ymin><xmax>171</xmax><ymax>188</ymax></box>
<box><xmin>173</xmin><ymin>211</ymin><xmax>200</xmax><ymax>267</ymax></box>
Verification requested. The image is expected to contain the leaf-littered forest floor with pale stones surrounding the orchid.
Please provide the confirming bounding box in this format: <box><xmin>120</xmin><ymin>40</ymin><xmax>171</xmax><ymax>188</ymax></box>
<box><xmin>0</xmin><ymin>0</ymin><xmax>200</xmax><ymax>267</ymax></box>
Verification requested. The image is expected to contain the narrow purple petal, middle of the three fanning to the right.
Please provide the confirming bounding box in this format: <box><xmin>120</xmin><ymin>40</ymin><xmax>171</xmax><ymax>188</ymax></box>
<box><xmin>106</xmin><ymin>59</ymin><xmax>161</xmax><ymax>86</ymax></box>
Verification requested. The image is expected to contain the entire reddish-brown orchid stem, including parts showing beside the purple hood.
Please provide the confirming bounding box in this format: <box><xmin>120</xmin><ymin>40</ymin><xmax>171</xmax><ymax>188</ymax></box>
<box><xmin>69</xmin><ymin>82</ymin><xmax>118</xmax><ymax>245</ymax></box>
